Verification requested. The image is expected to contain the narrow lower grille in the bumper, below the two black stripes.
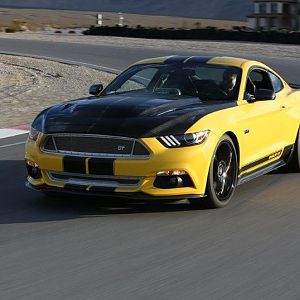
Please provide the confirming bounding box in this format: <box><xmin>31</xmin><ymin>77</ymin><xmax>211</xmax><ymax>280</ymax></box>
<box><xmin>47</xmin><ymin>171</ymin><xmax>142</xmax><ymax>188</ymax></box>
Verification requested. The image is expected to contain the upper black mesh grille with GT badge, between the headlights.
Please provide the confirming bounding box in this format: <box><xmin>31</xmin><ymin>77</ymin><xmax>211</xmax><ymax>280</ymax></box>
<box><xmin>41</xmin><ymin>134</ymin><xmax>150</xmax><ymax>158</ymax></box>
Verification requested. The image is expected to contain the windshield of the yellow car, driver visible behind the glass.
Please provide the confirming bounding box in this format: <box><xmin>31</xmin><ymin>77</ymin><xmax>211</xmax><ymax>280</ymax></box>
<box><xmin>102</xmin><ymin>63</ymin><xmax>241</xmax><ymax>101</ymax></box>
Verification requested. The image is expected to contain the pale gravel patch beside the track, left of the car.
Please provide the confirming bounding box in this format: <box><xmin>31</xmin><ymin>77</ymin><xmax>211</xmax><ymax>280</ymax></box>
<box><xmin>0</xmin><ymin>55</ymin><xmax>115</xmax><ymax>128</ymax></box>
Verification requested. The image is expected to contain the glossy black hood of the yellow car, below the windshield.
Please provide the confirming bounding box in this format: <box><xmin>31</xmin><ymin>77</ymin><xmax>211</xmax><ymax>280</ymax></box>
<box><xmin>33</xmin><ymin>94</ymin><xmax>236</xmax><ymax>138</ymax></box>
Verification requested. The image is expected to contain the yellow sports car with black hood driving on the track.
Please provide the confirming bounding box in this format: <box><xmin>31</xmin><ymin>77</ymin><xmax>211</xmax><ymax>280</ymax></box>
<box><xmin>25</xmin><ymin>56</ymin><xmax>300</xmax><ymax>207</ymax></box>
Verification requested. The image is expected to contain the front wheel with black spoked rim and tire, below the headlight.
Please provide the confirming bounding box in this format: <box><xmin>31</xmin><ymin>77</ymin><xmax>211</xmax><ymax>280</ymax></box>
<box><xmin>189</xmin><ymin>134</ymin><xmax>238</xmax><ymax>208</ymax></box>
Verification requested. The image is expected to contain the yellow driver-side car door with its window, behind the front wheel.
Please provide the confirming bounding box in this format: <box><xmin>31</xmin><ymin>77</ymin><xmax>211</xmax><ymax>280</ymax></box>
<box><xmin>240</xmin><ymin>67</ymin><xmax>287</xmax><ymax>170</ymax></box>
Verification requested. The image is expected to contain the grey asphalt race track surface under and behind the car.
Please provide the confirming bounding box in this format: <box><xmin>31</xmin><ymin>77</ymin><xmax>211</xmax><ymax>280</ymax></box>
<box><xmin>0</xmin><ymin>39</ymin><xmax>300</xmax><ymax>300</ymax></box>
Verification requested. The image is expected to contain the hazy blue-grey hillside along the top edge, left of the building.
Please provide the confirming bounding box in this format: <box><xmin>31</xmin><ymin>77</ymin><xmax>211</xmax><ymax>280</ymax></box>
<box><xmin>0</xmin><ymin>0</ymin><xmax>253</xmax><ymax>21</ymax></box>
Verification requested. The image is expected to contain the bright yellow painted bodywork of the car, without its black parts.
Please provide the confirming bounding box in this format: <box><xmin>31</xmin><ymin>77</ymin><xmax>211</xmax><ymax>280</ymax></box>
<box><xmin>25</xmin><ymin>57</ymin><xmax>300</xmax><ymax>196</ymax></box>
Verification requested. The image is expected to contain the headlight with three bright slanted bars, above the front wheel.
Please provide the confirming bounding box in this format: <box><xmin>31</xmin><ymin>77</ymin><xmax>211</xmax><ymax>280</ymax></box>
<box><xmin>157</xmin><ymin>130</ymin><xmax>210</xmax><ymax>148</ymax></box>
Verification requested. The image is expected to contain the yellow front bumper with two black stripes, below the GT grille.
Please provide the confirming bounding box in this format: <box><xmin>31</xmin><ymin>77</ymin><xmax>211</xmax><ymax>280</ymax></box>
<box><xmin>25</xmin><ymin>135</ymin><xmax>215</xmax><ymax>199</ymax></box>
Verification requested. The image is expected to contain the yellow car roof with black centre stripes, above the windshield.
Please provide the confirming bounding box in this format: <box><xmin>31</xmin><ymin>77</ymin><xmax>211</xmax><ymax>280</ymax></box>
<box><xmin>135</xmin><ymin>55</ymin><xmax>254</xmax><ymax>67</ymax></box>
